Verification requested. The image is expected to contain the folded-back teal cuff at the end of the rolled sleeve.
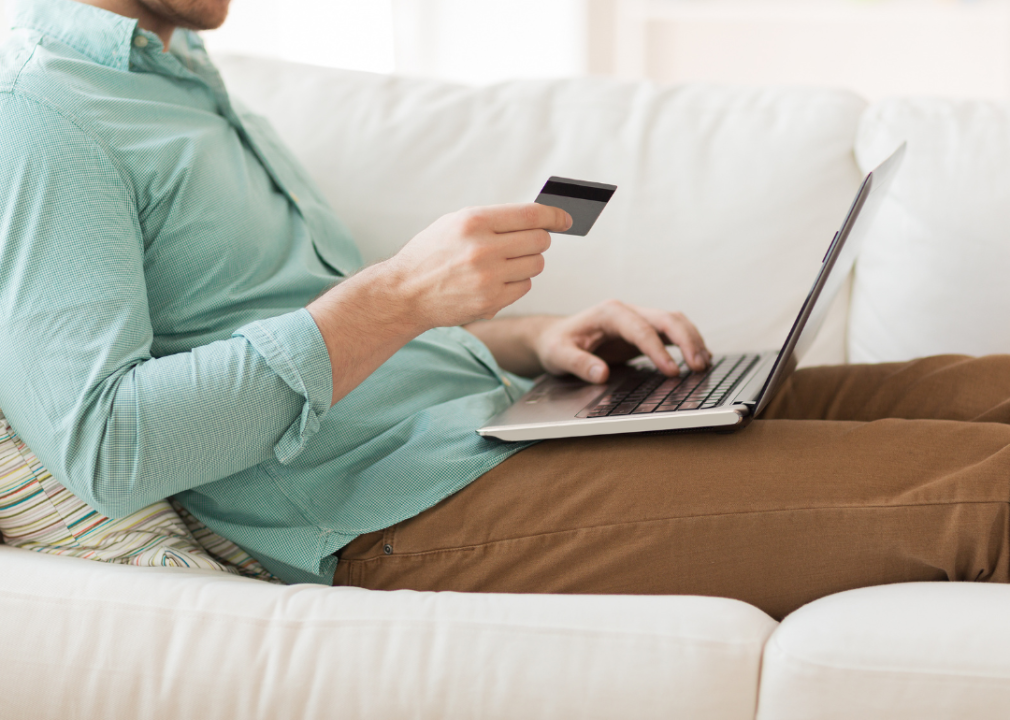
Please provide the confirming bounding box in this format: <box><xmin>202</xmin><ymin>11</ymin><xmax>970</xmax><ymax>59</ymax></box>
<box><xmin>232</xmin><ymin>308</ymin><xmax>333</xmax><ymax>465</ymax></box>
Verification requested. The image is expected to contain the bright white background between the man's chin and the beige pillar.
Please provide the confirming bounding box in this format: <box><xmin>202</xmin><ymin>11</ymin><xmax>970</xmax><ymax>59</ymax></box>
<box><xmin>204</xmin><ymin>0</ymin><xmax>587</xmax><ymax>84</ymax></box>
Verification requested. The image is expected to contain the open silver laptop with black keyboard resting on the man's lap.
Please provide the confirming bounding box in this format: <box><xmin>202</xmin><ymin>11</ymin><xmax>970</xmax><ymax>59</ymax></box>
<box><xmin>477</xmin><ymin>143</ymin><xmax>905</xmax><ymax>441</ymax></box>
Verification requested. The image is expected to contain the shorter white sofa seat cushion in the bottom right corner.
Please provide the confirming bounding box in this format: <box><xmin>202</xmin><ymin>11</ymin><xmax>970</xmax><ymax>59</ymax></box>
<box><xmin>758</xmin><ymin>583</ymin><xmax>1010</xmax><ymax>720</ymax></box>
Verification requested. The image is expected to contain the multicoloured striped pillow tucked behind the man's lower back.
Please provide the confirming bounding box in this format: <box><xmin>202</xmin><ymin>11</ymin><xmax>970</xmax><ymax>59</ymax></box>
<box><xmin>0</xmin><ymin>414</ymin><xmax>279</xmax><ymax>582</ymax></box>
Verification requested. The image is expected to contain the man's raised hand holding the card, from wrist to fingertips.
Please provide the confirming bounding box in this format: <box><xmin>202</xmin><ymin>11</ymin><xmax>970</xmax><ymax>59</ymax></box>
<box><xmin>381</xmin><ymin>203</ymin><xmax>572</xmax><ymax>327</ymax></box>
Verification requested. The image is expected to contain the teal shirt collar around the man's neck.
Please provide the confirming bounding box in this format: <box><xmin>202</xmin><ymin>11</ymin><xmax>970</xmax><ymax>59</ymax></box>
<box><xmin>12</xmin><ymin>0</ymin><xmax>203</xmax><ymax>71</ymax></box>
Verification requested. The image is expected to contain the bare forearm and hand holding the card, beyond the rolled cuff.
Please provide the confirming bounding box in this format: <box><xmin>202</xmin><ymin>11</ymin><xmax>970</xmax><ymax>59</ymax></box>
<box><xmin>306</xmin><ymin>204</ymin><xmax>572</xmax><ymax>403</ymax></box>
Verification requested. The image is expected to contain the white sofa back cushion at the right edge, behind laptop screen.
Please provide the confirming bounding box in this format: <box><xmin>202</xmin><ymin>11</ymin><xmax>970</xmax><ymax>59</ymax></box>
<box><xmin>848</xmin><ymin>99</ymin><xmax>1010</xmax><ymax>363</ymax></box>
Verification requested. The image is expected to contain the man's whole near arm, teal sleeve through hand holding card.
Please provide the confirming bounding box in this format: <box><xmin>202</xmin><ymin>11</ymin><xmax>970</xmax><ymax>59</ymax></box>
<box><xmin>0</xmin><ymin>95</ymin><xmax>569</xmax><ymax>517</ymax></box>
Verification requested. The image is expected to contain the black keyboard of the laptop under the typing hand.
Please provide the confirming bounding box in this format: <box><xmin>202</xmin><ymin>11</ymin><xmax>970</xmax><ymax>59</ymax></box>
<box><xmin>577</xmin><ymin>354</ymin><xmax>761</xmax><ymax>417</ymax></box>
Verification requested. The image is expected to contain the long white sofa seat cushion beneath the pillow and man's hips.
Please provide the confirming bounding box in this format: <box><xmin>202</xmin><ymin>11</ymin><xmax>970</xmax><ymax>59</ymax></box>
<box><xmin>0</xmin><ymin>546</ymin><xmax>776</xmax><ymax>720</ymax></box>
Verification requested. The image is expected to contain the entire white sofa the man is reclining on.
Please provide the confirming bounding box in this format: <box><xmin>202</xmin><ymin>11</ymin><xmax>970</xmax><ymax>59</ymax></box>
<box><xmin>0</xmin><ymin>53</ymin><xmax>1010</xmax><ymax>720</ymax></box>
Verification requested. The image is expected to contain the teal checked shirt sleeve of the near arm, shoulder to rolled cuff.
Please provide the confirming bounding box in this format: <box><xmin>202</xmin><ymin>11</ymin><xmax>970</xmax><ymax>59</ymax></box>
<box><xmin>0</xmin><ymin>94</ymin><xmax>332</xmax><ymax>517</ymax></box>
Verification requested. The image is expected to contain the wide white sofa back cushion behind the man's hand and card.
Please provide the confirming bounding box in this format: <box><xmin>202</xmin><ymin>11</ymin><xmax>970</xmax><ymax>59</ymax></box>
<box><xmin>217</xmin><ymin>58</ymin><xmax>865</xmax><ymax>362</ymax></box>
